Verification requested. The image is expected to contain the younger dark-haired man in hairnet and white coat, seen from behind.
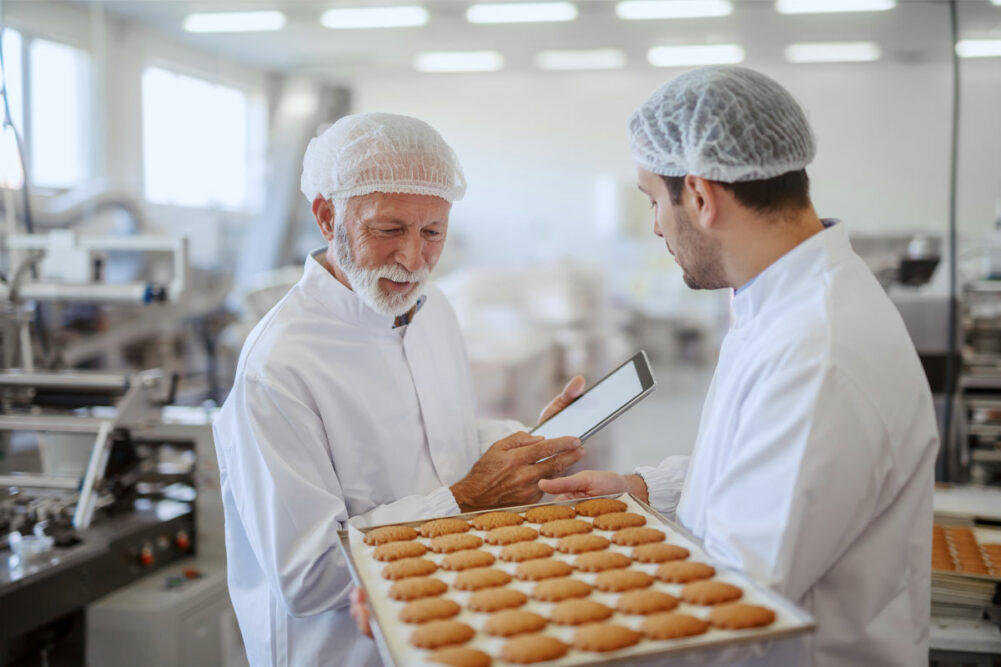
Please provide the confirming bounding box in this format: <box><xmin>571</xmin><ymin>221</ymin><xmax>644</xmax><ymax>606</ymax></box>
<box><xmin>540</xmin><ymin>67</ymin><xmax>938</xmax><ymax>666</ymax></box>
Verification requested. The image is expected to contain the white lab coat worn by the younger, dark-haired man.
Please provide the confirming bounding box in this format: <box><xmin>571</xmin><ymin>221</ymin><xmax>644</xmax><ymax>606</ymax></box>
<box><xmin>637</xmin><ymin>223</ymin><xmax>939</xmax><ymax>667</ymax></box>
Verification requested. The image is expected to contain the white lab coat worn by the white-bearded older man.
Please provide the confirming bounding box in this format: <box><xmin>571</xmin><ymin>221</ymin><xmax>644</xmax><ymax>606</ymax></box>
<box><xmin>214</xmin><ymin>250</ymin><xmax>520</xmax><ymax>667</ymax></box>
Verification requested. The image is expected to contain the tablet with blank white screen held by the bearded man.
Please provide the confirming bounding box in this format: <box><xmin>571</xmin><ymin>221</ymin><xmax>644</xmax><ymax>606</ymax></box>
<box><xmin>532</xmin><ymin>350</ymin><xmax>657</xmax><ymax>442</ymax></box>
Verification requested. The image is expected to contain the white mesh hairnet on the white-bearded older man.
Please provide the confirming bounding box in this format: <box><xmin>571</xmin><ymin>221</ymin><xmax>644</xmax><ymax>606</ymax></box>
<box><xmin>301</xmin><ymin>113</ymin><xmax>465</xmax><ymax>203</ymax></box>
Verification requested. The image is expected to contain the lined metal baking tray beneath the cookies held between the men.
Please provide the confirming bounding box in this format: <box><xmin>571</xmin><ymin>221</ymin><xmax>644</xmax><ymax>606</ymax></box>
<box><xmin>337</xmin><ymin>494</ymin><xmax>816</xmax><ymax>667</ymax></box>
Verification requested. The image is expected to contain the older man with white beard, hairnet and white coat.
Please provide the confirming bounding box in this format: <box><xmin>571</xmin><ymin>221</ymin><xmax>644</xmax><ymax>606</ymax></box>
<box><xmin>215</xmin><ymin>113</ymin><xmax>583</xmax><ymax>666</ymax></box>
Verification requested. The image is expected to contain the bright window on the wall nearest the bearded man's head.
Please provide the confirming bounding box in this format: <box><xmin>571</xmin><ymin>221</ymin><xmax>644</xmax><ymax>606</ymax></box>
<box><xmin>142</xmin><ymin>67</ymin><xmax>252</xmax><ymax>209</ymax></box>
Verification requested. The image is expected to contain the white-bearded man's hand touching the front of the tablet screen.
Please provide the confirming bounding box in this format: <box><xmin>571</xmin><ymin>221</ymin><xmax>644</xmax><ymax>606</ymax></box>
<box><xmin>451</xmin><ymin>432</ymin><xmax>584</xmax><ymax>512</ymax></box>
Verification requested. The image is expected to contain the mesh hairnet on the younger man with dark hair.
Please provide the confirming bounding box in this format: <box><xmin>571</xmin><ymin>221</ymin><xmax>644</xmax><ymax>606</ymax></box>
<box><xmin>629</xmin><ymin>66</ymin><xmax>817</xmax><ymax>183</ymax></box>
